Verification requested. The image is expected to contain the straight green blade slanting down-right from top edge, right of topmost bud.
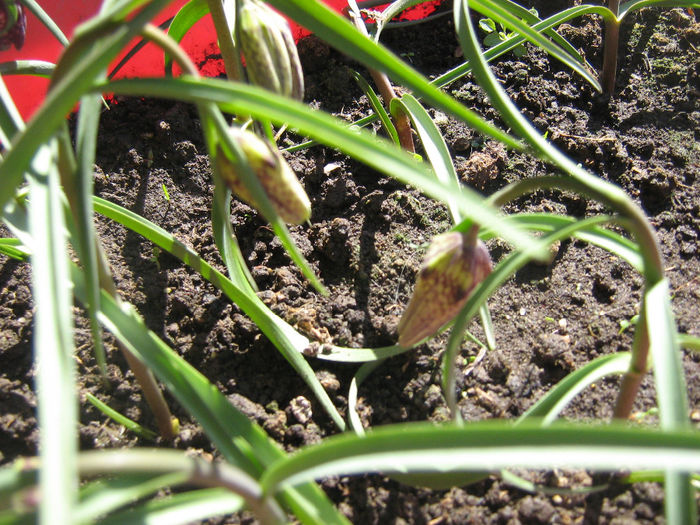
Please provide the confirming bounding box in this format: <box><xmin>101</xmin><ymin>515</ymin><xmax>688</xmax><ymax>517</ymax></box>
<box><xmin>268</xmin><ymin>0</ymin><xmax>520</xmax><ymax>149</ymax></box>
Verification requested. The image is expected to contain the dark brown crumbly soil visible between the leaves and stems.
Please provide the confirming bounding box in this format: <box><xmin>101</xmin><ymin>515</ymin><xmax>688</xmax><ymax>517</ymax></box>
<box><xmin>0</xmin><ymin>2</ymin><xmax>700</xmax><ymax>524</ymax></box>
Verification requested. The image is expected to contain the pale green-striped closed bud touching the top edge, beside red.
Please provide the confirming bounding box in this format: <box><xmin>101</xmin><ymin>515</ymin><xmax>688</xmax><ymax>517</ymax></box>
<box><xmin>238</xmin><ymin>0</ymin><xmax>304</xmax><ymax>100</ymax></box>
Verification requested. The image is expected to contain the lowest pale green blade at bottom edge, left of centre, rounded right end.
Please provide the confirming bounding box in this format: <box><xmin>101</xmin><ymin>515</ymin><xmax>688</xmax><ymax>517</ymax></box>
<box><xmin>100</xmin><ymin>488</ymin><xmax>243</xmax><ymax>525</ymax></box>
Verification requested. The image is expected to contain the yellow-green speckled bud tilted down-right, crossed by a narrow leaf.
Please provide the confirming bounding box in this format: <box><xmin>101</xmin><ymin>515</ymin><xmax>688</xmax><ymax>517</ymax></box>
<box><xmin>215</xmin><ymin>128</ymin><xmax>311</xmax><ymax>224</ymax></box>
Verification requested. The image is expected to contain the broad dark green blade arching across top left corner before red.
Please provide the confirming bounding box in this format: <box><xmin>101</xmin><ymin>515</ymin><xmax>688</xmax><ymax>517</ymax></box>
<box><xmin>0</xmin><ymin>0</ymin><xmax>172</xmax><ymax>210</ymax></box>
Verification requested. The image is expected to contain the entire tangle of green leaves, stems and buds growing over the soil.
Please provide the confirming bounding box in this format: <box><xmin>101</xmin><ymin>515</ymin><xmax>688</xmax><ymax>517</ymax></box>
<box><xmin>0</xmin><ymin>0</ymin><xmax>700</xmax><ymax>524</ymax></box>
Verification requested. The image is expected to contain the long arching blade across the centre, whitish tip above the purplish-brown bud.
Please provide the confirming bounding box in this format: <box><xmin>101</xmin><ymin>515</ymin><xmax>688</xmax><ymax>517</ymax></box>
<box><xmin>96</xmin><ymin>77</ymin><xmax>546</xmax><ymax>258</ymax></box>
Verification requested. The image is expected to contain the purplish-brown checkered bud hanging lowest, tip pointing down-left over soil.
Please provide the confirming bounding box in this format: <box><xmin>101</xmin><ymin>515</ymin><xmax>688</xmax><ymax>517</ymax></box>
<box><xmin>398</xmin><ymin>232</ymin><xmax>491</xmax><ymax>348</ymax></box>
